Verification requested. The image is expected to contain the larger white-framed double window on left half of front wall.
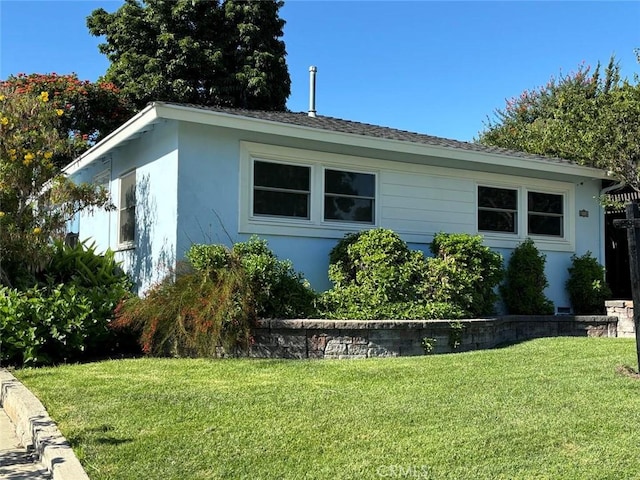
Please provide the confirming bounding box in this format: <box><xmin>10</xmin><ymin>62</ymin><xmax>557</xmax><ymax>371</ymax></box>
<box><xmin>244</xmin><ymin>142</ymin><xmax>379</xmax><ymax>232</ymax></box>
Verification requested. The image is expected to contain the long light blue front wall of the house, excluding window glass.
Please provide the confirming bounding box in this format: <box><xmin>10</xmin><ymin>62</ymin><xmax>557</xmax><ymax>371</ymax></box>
<box><xmin>172</xmin><ymin>123</ymin><xmax>603</xmax><ymax>307</ymax></box>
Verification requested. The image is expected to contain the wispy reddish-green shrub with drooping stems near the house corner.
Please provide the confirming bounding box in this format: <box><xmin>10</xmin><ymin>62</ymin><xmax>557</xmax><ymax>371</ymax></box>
<box><xmin>114</xmin><ymin>255</ymin><xmax>255</xmax><ymax>357</ymax></box>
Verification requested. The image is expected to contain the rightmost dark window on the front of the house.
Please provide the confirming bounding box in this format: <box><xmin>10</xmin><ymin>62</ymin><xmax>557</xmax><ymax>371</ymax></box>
<box><xmin>527</xmin><ymin>192</ymin><xmax>564</xmax><ymax>237</ymax></box>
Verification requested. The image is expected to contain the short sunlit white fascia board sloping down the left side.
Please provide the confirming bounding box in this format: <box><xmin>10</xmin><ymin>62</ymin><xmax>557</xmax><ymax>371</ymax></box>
<box><xmin>62</xmin><ymin>104</ymin><xmax>158</xmax><ymax>175</ymax></box>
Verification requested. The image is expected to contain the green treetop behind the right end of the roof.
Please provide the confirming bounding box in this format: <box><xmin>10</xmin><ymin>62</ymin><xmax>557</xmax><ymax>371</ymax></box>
<box><xmin>479</xmin><ymin>57</ymin><xmax>640</xmax><ymax>188</ymax></box>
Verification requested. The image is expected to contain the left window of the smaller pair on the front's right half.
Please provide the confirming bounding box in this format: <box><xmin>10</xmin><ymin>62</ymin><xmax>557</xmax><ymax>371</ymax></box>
<box><xmin>478</xmin><ymin>187</ymin><xmax>518</xmax><ymax>233</ymax></box>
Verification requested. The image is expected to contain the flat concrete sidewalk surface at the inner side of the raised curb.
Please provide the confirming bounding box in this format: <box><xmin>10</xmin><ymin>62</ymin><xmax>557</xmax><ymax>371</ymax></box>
<box><xmin>0</xmin><ymin>409</ymin><xmax>51</xmax><ymax>480</ymax></box>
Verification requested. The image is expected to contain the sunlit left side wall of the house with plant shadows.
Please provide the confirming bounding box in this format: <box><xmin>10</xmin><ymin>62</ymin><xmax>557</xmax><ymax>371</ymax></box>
<box><xmin>74</xmin><ymin>122</ymin><xmax>178</xmax><ymax>292</ymax></box>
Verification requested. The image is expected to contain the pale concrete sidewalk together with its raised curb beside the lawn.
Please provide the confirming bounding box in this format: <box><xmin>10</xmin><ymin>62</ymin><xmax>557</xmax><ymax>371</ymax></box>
<box><xmin>0</xmin><ymin>369</ymin><xmax>89</xmax><ymax>480</ymax></box>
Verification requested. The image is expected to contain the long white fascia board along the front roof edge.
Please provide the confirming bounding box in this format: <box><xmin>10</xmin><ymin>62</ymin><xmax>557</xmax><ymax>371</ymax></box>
<box><xmin>155</xmin><ymin>102</ymin><xmax>609</xmax><ymax>179</ymax></box>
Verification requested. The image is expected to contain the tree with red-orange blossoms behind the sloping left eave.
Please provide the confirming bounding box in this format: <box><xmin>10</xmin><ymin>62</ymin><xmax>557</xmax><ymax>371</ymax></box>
<box><xmin>0</xmin><ymin>73</ymin><xmax>133</xmax><ymax>168</ymax></box>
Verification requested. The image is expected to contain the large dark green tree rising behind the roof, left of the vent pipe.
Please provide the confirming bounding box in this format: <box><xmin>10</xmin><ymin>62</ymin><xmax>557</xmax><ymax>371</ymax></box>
<box><xmin>87</xmin><ymin>0</ymin><xmax>291</xmax><ymax>110</ymax></box>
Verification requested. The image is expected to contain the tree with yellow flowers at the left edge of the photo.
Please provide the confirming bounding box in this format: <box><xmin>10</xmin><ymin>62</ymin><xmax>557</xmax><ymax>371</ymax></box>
<box><xmin>0</xmin><ymin>85</ymin><xmax>110</xmax><ymax>285</ymax></box>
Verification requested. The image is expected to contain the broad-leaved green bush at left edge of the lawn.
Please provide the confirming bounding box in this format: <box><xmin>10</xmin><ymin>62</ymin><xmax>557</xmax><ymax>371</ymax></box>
<box><xmin>0</xmin><ymin>243</ymin><xmax>130</xmax><ymax>365</ymax></box>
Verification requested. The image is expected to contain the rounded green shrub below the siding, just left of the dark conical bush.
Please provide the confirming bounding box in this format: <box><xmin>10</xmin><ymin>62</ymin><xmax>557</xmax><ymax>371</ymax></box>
<box><xmin>425</xmin><ymin>232</ymin><xmax>504</xmax><ymax>317</ymax></box>
